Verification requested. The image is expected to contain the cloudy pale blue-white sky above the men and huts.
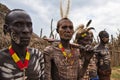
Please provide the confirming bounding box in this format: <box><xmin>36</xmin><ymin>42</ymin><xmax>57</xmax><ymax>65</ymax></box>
<box><xmin>0</xmin><ymin>0</ymin><xmax>120</xmax><ymax>40</ymax></box>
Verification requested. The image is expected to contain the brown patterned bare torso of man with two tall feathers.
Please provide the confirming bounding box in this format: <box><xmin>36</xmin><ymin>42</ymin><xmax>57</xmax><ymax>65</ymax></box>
<box><xmin>44</xmin><ymin>44</ymin><xmax>81</xmax><ymax>80</ymax></box>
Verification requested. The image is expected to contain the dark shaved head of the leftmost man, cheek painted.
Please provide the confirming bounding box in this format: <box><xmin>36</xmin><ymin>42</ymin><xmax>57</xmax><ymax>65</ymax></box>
<box><xmin>3</xmin><ymin>9</ymin><xmax>33</xmax><ymax>46</ymax></box>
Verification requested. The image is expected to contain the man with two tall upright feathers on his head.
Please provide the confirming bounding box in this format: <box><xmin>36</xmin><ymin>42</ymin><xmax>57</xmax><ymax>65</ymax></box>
<box><xmin>44</xmin><ymin>18</ymin><xmax>94</xmax><ymax>80</ymax></box>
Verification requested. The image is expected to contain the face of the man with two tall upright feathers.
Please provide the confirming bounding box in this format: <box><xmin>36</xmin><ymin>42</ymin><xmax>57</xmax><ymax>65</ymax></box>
<box><xmin>58</xmin><ymin>20</ymin><xmax>74</xmax><ymax>40</ymax></box>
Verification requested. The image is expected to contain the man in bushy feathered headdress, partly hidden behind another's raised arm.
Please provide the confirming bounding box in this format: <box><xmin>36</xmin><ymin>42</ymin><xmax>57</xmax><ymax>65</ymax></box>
<box><xmin>75</xmin><ymin>20</ymin><xmax>98</xmax><ymax>80</ymax></box>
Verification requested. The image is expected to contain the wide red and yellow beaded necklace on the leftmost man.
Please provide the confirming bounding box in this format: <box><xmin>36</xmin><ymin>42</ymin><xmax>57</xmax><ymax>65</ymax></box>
<box><xmin>9</xmin><ymin>46</ymin><xmax>30</xmax><ymax>70</ymax></box>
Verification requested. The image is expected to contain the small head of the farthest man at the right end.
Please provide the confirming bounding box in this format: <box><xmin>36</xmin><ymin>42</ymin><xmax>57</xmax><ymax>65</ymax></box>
<box><xmin>99</xmin><ymin>30</ymin><xmax>109</xmax><ymax>44</ymax></box>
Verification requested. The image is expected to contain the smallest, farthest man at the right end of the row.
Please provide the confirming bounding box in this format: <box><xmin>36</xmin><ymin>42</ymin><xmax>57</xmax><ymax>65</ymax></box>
<box><xmin>96</xmin><ymin>30</ymin><xmax>111</xmax><ymax>80</ymax></box>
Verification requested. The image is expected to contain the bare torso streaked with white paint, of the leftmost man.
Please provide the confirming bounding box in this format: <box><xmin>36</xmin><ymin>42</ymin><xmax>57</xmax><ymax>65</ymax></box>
<box><xmin>0</xmin><ymin>48</ymin><xmax>44</xmax><ymax>80</ymax></box>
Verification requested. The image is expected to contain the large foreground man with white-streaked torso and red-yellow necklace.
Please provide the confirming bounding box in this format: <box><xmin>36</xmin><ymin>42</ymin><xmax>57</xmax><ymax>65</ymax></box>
<box><xmin>0</xmin><ymin>9</ymin><xmax>44</xmax><ymax>80</ymax></box>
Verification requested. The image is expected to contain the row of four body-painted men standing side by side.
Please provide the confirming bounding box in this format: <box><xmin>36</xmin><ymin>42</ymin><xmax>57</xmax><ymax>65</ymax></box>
<box><xmin>0</xmin><ymin>9</ymin><xmax>111</xmax><ymax>80</ymax></box>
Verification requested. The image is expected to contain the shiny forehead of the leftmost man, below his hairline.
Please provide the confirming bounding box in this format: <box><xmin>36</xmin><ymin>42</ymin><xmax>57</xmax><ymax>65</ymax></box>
<box><xmin>8</xmin><ymin>11</ymin><xmax>31</xmax><ymax>22</ymax></box>
